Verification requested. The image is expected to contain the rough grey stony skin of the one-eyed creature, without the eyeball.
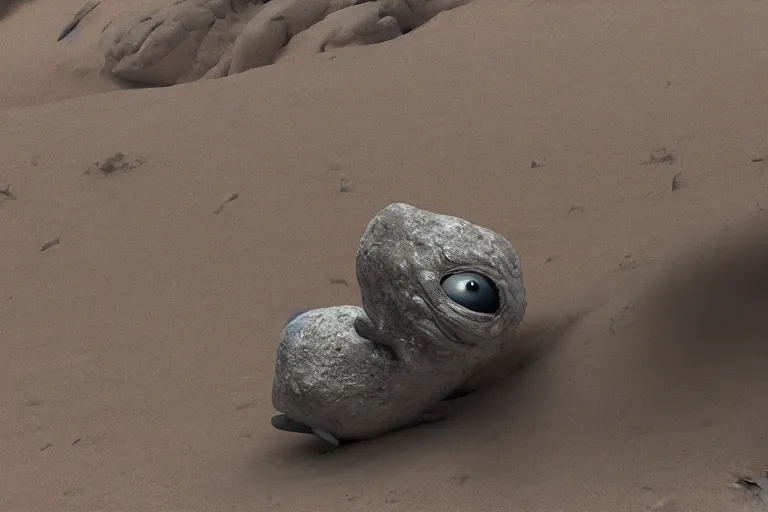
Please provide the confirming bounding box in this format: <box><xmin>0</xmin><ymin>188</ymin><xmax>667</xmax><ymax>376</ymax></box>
<box><xmin>272</xmin><ymin>203</ymin><xmax>526</xmax><ymax>439</ymax></box>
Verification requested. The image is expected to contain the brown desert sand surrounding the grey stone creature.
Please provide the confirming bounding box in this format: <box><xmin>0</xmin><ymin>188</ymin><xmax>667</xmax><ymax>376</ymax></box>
<box><xmin>0</xmin><ymin>0</ymin><xmax>768</xmax><ymax>512</ymax></box>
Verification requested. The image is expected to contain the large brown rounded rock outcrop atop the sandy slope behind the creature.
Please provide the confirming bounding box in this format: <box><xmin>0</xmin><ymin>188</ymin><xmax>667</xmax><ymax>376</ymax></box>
<box><xmin>102</xmin><ymin>0</ymin><xmax>469</xmax><ymax>86</ymax></box>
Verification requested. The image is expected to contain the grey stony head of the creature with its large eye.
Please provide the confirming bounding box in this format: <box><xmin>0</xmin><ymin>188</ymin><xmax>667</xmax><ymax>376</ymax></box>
<box><xmin>357</xmin><ymin>203</ymin><xmax>526</xmax><ymax>362</ymax></box>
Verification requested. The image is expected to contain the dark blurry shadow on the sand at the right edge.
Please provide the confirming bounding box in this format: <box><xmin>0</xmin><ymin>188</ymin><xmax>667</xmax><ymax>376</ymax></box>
<box><xmin>638</xmin><ymin>220</ymin><xmax>768</xmax><ymax>383</ymax></box>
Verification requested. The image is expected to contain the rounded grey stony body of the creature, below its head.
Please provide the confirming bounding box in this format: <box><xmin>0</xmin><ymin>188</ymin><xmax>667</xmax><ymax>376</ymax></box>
<box><xmin>273</xmin><ymin>306</ymin><xmax>468</xmax><ymax>439</ymax></box>
